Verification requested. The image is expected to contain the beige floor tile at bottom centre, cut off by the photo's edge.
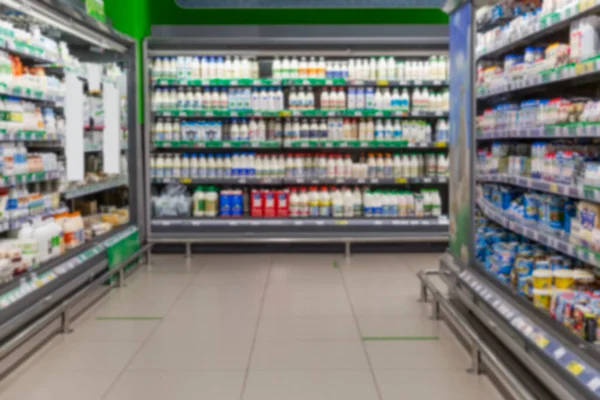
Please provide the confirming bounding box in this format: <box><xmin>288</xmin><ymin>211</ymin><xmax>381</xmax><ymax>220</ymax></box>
<box><xmin>242</xmin><ymin>370</ymin><xmax>377</xmax><ymax>400</ymax></box>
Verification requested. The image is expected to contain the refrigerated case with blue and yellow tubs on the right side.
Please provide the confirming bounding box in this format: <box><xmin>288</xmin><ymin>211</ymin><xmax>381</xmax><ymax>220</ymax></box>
<box><xmin>441</xmin><ymin>0</ymin><xmax>600</xmax><ymax>399</ymax></box>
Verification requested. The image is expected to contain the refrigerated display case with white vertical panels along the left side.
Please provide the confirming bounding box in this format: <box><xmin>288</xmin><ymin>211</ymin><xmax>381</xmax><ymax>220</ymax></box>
<box><xmin>0</xmin><ymin>0</ymin><xmax>144</xmax><ymax>373</ymax></box>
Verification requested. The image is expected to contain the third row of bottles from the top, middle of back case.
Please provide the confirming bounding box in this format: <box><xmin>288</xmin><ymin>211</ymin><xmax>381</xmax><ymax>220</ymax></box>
<box><xmin>152</xmin><ymin>118</ymin><xmax>449</xmax><ymax>144</ymax></box>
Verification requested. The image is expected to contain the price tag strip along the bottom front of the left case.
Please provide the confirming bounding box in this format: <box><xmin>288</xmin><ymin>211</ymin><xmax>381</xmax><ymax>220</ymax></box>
<box><xmin>0</xmin><ymin>226</ymin><xmax>138</xmax><ymax>310</ymax></box>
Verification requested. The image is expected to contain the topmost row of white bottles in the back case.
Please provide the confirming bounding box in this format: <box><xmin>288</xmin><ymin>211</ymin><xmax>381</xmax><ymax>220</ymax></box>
<box><xmin>152</xmin><ymin>56</ymin><xmax>448</xmax><ymax>82</ymax></box>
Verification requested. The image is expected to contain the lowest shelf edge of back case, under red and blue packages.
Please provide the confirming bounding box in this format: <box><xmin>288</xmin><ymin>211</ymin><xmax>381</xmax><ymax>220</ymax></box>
<box><xmin>152</xmin><ymin>216</ymin><xmax>448</xmax><ymax>227</ymax></box>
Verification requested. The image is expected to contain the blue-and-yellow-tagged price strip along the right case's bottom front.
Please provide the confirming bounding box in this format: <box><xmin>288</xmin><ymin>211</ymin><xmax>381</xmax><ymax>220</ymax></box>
<box><xmin>459</xmin><ymin>269</ymin><xmax>600</xmax><ymax>397</ymax></box>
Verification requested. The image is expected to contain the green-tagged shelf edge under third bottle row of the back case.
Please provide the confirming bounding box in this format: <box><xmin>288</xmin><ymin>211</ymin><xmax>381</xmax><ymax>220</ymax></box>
<box><xmin>152</xmin><ymin>140</ymin><xmax>448</xmax><ymax>151</ymax></box>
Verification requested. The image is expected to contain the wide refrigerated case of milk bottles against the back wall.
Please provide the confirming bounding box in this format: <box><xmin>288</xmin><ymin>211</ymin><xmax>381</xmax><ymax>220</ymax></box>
<box><xmin>144</xmin><ymin>26</ymin><xmax>448</xmax><ymax>249</ymax></box>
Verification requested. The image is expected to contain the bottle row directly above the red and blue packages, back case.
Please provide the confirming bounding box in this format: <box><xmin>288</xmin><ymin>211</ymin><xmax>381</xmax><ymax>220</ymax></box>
<box><xmin>150</xmin><ymin>153</ymin><xmax>448</xmax><ymax>179</ymax></box>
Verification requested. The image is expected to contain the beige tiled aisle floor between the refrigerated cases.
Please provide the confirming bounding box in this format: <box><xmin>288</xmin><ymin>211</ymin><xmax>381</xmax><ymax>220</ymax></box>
<box><xmin>0</xmin><ymin>254</ymin><xmax>501</xmax><ymax>400</ymax></box>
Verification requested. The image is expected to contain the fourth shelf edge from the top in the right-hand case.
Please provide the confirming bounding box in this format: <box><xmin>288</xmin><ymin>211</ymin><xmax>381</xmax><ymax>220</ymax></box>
<box><xmin>477</xmin><ymin>174</ymin><xmax>600</xmax><ymax>203</ymax></box>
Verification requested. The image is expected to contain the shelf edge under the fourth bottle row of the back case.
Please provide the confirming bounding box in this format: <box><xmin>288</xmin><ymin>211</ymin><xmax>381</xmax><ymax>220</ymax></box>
<box><xmin>151</xmin><ymin>177</ymin><xmax>448</xmax><ymax>186</ymax></box>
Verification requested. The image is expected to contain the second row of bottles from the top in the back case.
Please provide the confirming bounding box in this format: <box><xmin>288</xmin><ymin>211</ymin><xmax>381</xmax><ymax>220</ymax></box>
<box><xmin>152</xmin><ymin>87</ymin><xmax>449</xmax><ymax>112</ymax></box>
